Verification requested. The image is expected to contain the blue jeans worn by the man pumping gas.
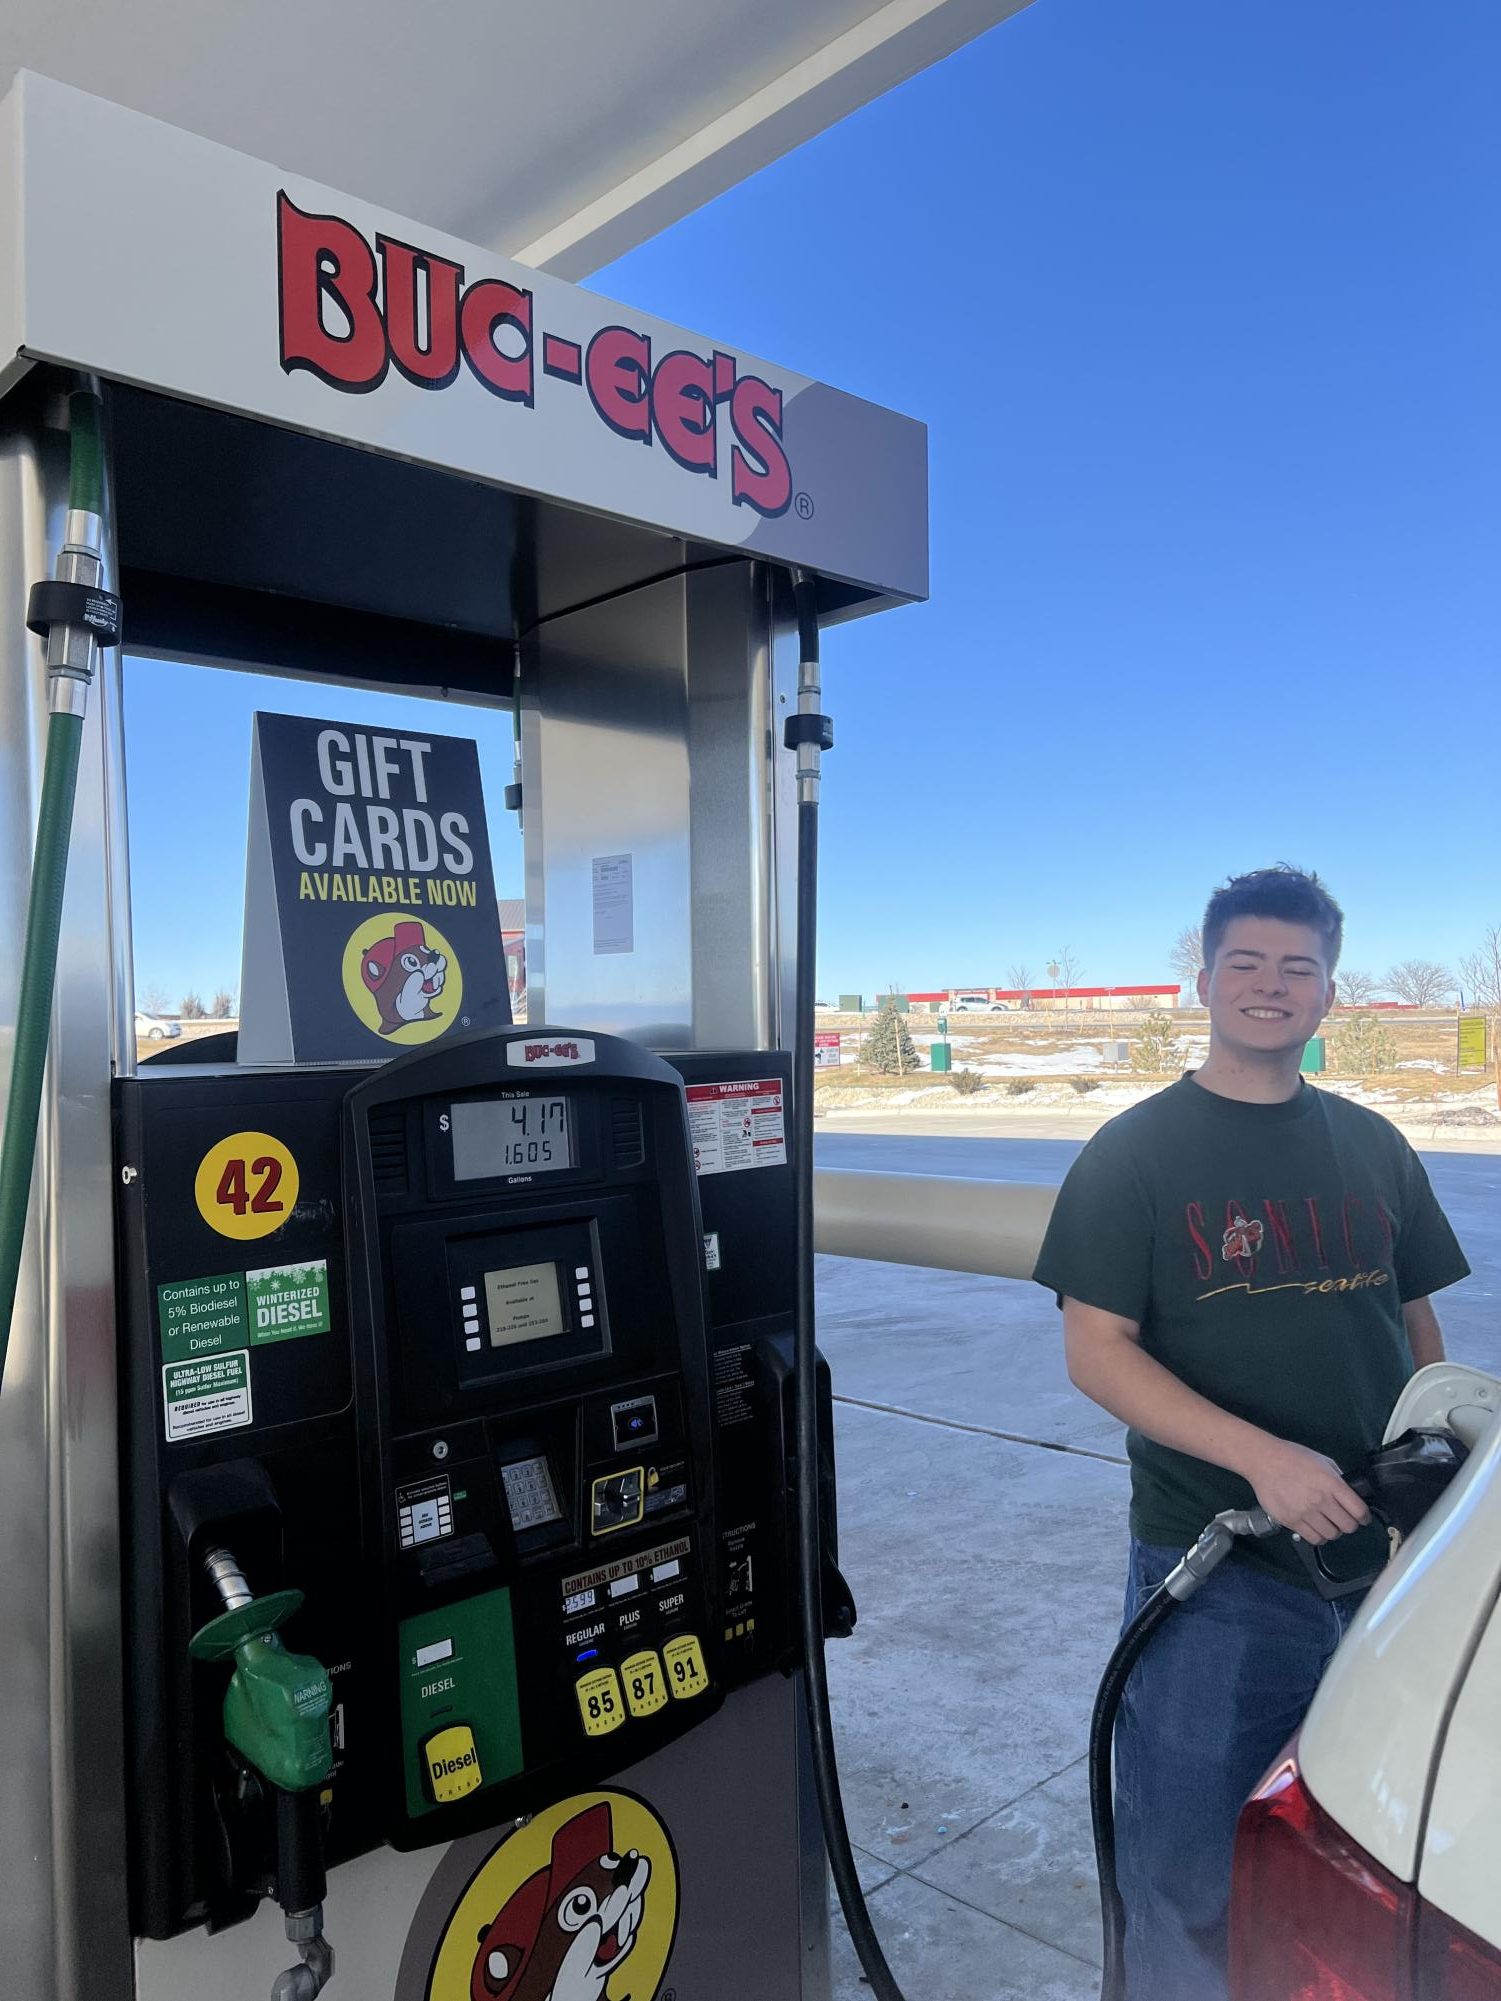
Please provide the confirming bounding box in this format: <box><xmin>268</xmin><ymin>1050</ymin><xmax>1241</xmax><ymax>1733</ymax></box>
<box><xmin>1115</xmin><ymin>1541</ymin><xmax>1359</xmax><ymax>2001</ymax></box>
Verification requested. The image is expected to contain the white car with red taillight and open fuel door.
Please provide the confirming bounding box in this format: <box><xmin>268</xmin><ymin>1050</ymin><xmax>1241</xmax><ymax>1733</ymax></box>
<box><xmin>1231</xmin><ymin>1363</ymin><xmax>1501</xmax><ymax>2001</ymax></box>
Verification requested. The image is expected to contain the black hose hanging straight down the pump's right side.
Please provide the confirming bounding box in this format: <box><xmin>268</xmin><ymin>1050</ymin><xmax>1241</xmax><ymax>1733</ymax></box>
<box><xmin>793</xmin><ymin>576</ymin><xmax>905</xmax><ymax>2001</ymax></box>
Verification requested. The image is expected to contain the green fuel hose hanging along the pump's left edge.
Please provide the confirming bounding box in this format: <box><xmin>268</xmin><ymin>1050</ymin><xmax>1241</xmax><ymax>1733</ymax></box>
<box><xmin>0</xmin><ymin>390</ymin><xmax>104</xmax><ymax>1383</ymax></box>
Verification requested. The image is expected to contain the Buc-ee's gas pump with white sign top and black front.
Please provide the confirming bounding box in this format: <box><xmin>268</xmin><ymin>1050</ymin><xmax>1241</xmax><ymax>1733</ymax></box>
<box><xmin>0</xmin><ymin>66</ymin><xmax>927</xmax><ymax>2001</ymax></box>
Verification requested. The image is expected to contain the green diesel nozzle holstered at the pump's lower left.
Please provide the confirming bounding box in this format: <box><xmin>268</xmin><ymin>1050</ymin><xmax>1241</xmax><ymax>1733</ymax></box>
<box><xmin>188</xmin><ymin>1549</ymin><xmax>334</xmax><ymax>2001</ymax></box>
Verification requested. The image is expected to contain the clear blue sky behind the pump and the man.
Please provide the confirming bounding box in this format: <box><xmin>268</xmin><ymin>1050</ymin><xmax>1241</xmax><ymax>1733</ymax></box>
<box><xmin>132</xmin><ymin>0</ymin><xmax>1501</xmax><ymax>998</ymax></box>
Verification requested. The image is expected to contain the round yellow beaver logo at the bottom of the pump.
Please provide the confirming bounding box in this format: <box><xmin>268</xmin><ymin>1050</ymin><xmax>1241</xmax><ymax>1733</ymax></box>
<box><xmin>424</xmin><ymin>1793</ymin><xmax>678</xmax><ymax>2001</ymax></box>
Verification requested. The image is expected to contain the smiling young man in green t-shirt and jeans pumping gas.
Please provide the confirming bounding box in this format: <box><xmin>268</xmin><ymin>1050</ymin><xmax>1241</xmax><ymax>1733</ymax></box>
<box><xmin>1037</xmin><ymin>868</ymin><xmax>1469</xmax><ymax>2001</ymax></box>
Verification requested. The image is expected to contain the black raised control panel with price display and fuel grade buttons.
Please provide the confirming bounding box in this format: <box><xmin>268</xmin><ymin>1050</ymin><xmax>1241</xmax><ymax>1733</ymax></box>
<box><xmin>344</xmin><ymin>1029</ymin><xmax>720</xmax><ymax>1847</ymax></box>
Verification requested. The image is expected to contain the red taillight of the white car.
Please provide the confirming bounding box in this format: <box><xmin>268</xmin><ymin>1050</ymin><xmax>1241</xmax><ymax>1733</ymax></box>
<box><xmin>1231</xmin><ymin>1751</ymin><xmax>1501</xmax><ymax>2001</ymax></box>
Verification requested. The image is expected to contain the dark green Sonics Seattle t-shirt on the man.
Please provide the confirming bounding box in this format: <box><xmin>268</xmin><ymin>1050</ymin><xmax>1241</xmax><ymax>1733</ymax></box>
<box><xmin>1035</xmin><ymin>1075</ymin><xmax>1469</xmax><ymax>1583</ymax></box>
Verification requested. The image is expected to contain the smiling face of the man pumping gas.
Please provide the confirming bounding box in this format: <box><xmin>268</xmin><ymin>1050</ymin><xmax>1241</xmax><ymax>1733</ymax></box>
<box><xmin>1199</xmin><ymin>916</ymin><xmax>1335</xmax><ymax>1063</ymax></box>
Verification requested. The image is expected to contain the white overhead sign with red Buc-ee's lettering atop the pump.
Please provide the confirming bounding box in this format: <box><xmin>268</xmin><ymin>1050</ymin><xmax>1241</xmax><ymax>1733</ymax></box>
<box><xmin>0</xmin><ymin>74</ymin><xmax>927</xmax><ymax>598</ymax></box>
